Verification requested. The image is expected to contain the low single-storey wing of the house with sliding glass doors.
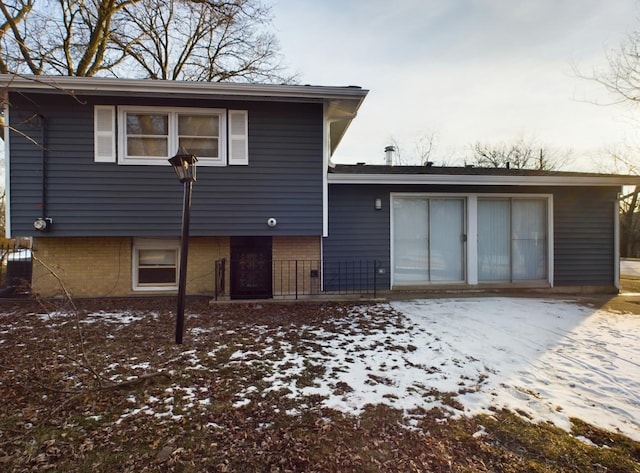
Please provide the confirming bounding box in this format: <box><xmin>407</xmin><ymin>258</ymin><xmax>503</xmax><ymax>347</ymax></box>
<box><xmin>323</xmin><ymin>165</ymin><xmax>640</xmax><ymax>292</ymax></box>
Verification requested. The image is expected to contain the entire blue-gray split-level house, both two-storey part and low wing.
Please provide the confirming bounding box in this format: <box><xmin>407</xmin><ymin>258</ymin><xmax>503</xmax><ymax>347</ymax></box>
<box><xmin>0</xmin><ymin>76</ymin><xmax>640</xmax><ymax>299</ymax></box>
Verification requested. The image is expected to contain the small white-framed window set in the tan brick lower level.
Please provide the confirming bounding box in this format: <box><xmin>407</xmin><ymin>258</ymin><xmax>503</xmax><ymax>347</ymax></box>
<box><xmin>133</xmin><ymin>239</ymin><xmax>180</xmax><ymax>291</ymax></box>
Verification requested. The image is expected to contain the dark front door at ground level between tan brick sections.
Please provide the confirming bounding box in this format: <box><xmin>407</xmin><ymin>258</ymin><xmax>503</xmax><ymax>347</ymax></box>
<box><xmin>230</xmin><ymin>237</ymin><xmax>273</xmax><ymax>299</ymax></box>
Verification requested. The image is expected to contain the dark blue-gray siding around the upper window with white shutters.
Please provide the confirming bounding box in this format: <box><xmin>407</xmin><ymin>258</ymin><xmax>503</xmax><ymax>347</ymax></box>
<box><xmin>10</xmin><ymin>95</ymin><xmax>323</xmax><ymax>236</ymax></box>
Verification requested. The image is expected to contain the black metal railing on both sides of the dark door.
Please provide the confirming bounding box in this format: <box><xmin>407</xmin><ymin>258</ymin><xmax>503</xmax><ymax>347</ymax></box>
<box><xmin>214</xmin><ymin>259</ymin><xmax>388</xmax><ymax>300</ymax></box>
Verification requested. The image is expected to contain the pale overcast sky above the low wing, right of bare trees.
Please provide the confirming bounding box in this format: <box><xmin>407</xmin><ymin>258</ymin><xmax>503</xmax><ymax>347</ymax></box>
<box><xmin>272</xmin><ymin>0</ymin><xmax>640</xmax><ymax>170</ymax></box>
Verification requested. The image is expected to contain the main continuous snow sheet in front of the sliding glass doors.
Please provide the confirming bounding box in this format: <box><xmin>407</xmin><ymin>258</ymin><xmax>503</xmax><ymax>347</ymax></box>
<box><xmin>255</xmin><ymin>297</ymin><xmax>640</xmax><ymax>440</ymax></box>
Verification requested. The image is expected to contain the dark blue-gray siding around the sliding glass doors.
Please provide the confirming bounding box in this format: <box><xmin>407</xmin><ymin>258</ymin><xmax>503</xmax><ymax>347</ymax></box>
<box><xmin>323</xmin><ymin>184</ymin><xmax>620</xmax><ymax>287</ymax></box>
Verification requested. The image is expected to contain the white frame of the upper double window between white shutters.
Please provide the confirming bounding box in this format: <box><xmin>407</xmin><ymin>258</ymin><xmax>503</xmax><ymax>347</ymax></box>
<box><xmin>118</xmin><ymin>105</ymin><xmax>228</xmax><ymax>166</ymax></box>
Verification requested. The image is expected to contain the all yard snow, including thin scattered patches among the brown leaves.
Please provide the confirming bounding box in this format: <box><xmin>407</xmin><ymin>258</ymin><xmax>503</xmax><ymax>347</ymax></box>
<box><xmin>40</xmin><ymin>297</ymin><xmax>640</xmax><ymax>441</ymax></box>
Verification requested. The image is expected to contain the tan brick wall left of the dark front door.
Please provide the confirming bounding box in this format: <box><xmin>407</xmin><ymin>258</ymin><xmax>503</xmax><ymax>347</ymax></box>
<box><xmin>32</xmin><ymin>237</ymin><xmax>229</xmax><ymax>297</ymax></box>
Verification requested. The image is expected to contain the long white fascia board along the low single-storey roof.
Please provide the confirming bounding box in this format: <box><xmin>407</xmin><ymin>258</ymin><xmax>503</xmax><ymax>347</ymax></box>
<box><xmin>328</xmin><ymin>173</ymin><xmax>640</xmax><ymax>186</ymax></box>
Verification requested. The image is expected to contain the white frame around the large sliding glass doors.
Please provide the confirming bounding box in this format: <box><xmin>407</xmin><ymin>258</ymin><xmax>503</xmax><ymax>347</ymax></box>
<box><xmin>389</xmin><ymin>192</ymin><xmax>554</xmax><ymax>288</ymax></box>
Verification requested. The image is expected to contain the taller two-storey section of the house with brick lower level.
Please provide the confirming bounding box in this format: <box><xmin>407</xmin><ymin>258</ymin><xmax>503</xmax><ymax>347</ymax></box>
<box><xmin>0</xmin><ymin>76</ymin><xmax>367</xmax><ymax>298</ymax></box>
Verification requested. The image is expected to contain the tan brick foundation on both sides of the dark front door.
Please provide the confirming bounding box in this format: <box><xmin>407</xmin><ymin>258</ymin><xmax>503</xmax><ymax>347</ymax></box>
<box><xmin>32</xmin><ymin>236</ymin><xmax>321</xmax><ymax>297</ymax></box>
